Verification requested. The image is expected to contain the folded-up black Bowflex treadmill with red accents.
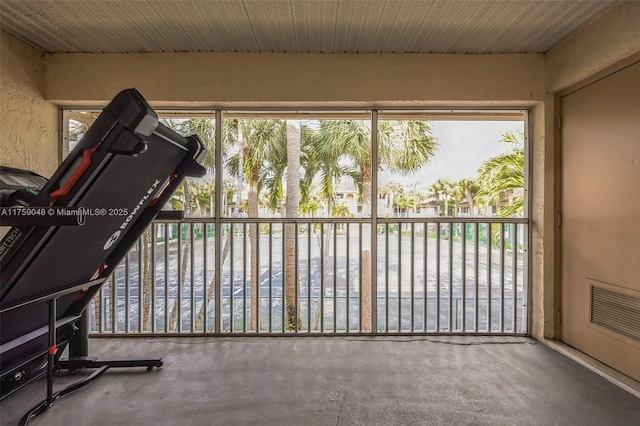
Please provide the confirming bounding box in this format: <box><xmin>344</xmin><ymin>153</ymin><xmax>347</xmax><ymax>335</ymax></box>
<box><xmin>0</xmin><ymin>89</ymin><xmax>206</xmax><ymax>424</ymax></box>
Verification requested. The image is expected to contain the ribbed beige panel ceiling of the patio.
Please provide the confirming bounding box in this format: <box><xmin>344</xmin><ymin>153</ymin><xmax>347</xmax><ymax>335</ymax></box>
<box><xmin>0</xmin><ymin>0</ymin><xmax>616</xmax><ymax>53</ymax></box>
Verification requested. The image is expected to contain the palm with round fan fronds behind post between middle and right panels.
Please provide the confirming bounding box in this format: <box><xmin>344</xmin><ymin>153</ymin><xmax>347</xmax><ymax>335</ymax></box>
<box><xmin>320</xmin><ymin>120</ymin><xmax>437</xmax><ymax>331</ymax></box>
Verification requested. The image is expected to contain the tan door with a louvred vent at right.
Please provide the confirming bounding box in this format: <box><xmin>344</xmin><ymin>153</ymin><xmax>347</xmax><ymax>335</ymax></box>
<box><xmin>560</xmin><ymin>62</ymin><xmax>640</xmax><ymax>380</ymax></box>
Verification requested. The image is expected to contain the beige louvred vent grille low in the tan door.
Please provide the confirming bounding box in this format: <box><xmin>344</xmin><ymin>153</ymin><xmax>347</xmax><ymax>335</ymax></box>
<box><xmin>591</xmin><ymin>285</ymin><xmax>640</xmax><ymax>342</ymax></box>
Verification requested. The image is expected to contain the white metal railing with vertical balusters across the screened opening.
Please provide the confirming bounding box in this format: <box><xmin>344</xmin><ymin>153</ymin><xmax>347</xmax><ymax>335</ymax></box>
<box><xmin>90</xmin><ymin>218</ymin><xmax>528</xmax><ymax>335</ymax></box>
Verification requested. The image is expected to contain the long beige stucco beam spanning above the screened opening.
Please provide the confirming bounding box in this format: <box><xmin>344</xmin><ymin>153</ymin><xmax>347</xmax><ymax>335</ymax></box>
<box><xmin>45</xmin><ymin>53</ymin><xmax>545</xmax><ymax>107</ymax></box>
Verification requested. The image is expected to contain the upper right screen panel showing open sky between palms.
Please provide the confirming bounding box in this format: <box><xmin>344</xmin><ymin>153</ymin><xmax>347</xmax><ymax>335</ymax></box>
<box><xmin>377</xmin><ymin>114</ymin><xmax>525</xmax><ymax>217</ymax></box>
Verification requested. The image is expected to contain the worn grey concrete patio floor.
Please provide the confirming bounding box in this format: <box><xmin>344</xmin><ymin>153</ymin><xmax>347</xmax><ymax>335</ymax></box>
<box><xmin>0</xmin><ymin>337</ymin><xmax>640</xmax><ymax>426</ymax></box>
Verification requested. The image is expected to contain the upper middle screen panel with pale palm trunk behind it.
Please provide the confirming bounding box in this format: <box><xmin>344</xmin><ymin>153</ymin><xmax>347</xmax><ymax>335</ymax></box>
<box><xmin>223</xmin><ymin>113</ymin><xmax>371</xmax><ymax>218</ymax></box>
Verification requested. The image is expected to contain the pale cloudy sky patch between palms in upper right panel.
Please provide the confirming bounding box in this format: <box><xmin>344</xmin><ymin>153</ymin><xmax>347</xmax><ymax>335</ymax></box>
<box><xmin>378</xmin><ymin>121</ymin><xmax>524</xmax><ymax>191</ymax></box>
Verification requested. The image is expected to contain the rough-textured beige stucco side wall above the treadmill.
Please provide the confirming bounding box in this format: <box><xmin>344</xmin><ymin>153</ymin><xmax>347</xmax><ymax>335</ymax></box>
<box><xmin>0</xmin><ymin>31</ymin><xmax>59</xmax><ymax>177</ymax></box>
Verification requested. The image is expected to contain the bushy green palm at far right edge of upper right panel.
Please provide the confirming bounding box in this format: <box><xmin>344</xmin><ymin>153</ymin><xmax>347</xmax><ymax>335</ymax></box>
<box><xmin>477</xmin><ymin>131</ymin><xmax>524</xmax><ymax>217</ymax></box>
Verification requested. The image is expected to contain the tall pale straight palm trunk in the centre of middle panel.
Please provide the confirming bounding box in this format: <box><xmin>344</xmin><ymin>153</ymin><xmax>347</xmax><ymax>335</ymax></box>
<box><xmin>284</xmin><ymin>120</ymin><xmax>303</xmax><ymax>330</ymax></box>
